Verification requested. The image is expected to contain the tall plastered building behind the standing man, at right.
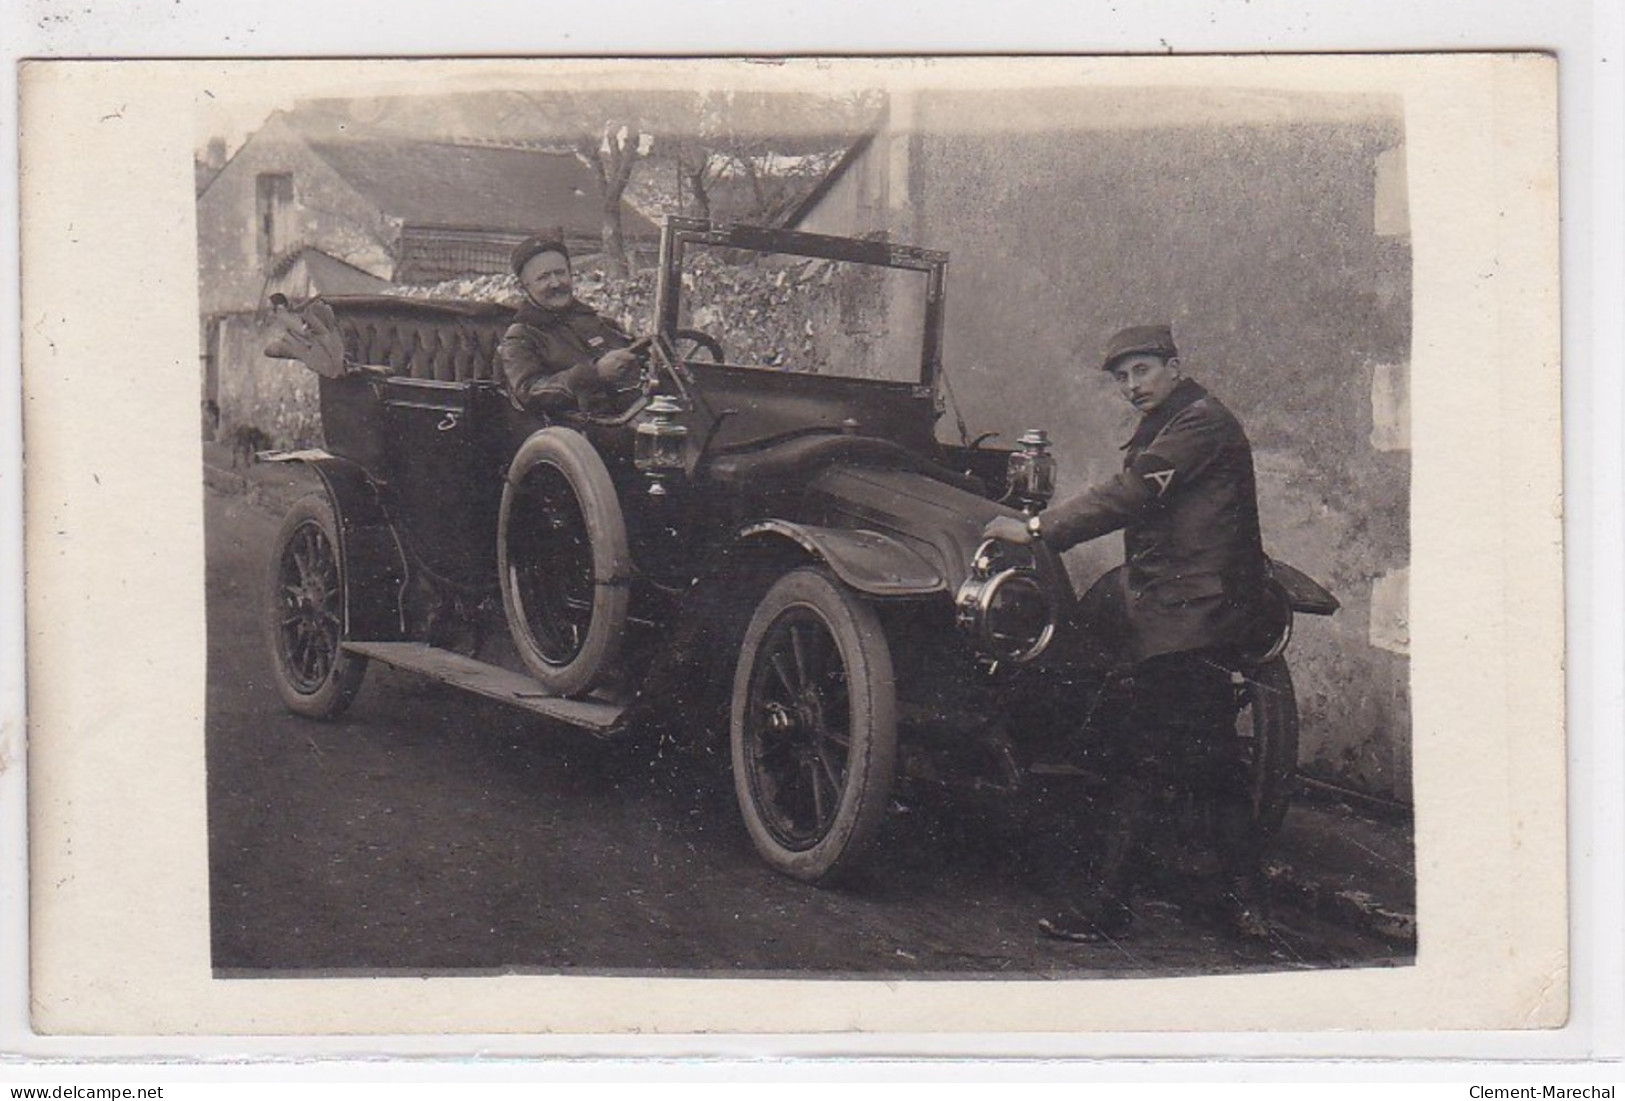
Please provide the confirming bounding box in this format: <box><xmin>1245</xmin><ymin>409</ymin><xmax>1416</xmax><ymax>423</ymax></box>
<box><xmin>787</xmin><ymin>88</ymin><xmax>1411</xmax><ymax>804</ymax></box>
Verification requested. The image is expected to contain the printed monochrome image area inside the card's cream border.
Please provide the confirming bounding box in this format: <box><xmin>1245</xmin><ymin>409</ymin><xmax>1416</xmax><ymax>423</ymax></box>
<box><xmin>197</xmin><ymin>62</ymin><xmax>1417</xmax><ymax>978</ymax></box>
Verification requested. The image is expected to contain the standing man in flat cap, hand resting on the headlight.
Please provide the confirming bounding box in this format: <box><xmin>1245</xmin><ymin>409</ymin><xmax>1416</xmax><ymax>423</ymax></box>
<box><xmin>985</xmin><ymin>325</ymin><xmax>1269</xmax><ymax>942</ymax></box>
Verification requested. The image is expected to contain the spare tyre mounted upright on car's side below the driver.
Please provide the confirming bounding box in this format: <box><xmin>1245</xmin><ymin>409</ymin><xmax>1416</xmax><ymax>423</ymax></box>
<box><xmin>497</xmin><ymin>425</ymin><xmax>632</xmax><ymax>695</ymax></box>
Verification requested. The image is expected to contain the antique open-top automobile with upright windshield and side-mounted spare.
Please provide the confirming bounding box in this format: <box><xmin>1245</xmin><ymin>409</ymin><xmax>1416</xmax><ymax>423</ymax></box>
<box><xmin>267</xmin><ymin>218</ymin><xmax>1336</xmax><ymax>882</ymax></box>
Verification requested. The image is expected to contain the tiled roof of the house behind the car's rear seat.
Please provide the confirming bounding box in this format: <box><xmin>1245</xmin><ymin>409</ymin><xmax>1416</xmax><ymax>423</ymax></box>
<box><xmin>310</xmin><ymin>140</ymin><xmax>658</xmax><ymax>237</ymax></box>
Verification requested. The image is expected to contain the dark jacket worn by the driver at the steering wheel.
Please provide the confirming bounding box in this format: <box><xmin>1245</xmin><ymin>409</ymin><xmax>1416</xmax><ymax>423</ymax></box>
<box><xmin>497</xmin><ymin>299</ymin><xmax>632</xmax><ymax>412</ymax></box>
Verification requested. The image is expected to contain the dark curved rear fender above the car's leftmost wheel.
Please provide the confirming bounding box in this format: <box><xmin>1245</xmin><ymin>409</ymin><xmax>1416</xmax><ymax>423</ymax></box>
<box><xmin>263</xmin><ymin>448</ymin><xmax>406</xmax><ymax>641</ymax></box>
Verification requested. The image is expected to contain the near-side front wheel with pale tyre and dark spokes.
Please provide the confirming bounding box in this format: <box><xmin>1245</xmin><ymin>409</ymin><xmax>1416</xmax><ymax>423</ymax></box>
<box><xmin>730</xmin><ymin>567</ymin><xmax>897</xmax><ymax>883</ymax></box>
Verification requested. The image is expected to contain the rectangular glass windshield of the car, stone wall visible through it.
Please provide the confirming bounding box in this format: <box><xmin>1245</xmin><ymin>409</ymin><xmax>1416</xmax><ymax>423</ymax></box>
<box><xmin>678</xmin><ymin>240</ymin><xmax>930</xmax><ymax>383</ymax></box>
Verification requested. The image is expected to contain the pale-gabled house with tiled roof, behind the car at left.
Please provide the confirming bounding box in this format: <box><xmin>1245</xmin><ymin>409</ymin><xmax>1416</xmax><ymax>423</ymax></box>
<box><xmin>197</xmin><ymin>112</ymin><xmax>660</xmax><ymax>442</ymax></box>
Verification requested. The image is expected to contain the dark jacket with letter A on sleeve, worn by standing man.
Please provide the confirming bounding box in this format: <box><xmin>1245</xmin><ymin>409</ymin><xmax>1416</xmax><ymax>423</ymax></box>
<box><xmin>1042</xmin><ymin>378</ymin><xmax>1268</xmax><ymax>661</ymax></box>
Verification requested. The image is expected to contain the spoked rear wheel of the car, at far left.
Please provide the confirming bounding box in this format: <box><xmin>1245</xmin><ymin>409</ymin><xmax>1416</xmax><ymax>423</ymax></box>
<box><xmin>265</xmin><ymin>494</ymin><xmax>367</xmax><ymax>719</ymax></box>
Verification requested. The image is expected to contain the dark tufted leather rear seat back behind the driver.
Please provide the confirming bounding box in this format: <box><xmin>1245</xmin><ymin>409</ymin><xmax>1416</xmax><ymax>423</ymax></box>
<box><xmin>327</xmin><ymin>296</ymin><xmax>514</xmax><ymax>382</ymax></box>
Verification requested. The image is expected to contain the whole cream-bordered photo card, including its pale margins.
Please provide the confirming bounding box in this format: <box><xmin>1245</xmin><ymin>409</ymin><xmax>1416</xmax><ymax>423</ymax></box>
<box><xmin>9</xmin><ymin>55</ymin><xmax>1567</xmax><ymax>1034</ymax></box>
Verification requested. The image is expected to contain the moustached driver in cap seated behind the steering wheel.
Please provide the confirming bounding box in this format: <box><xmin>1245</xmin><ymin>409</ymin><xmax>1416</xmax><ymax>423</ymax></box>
<box><xmin>497</xmin><ymin>237</ymin><xmax>639</xmax><ymax>416</ymax></box>
